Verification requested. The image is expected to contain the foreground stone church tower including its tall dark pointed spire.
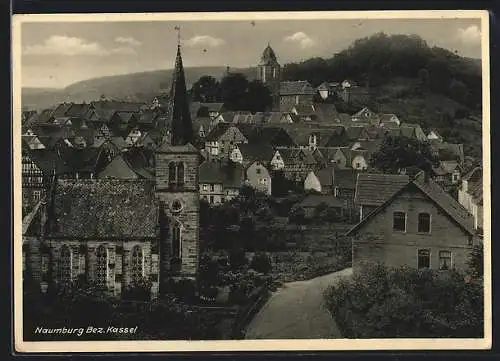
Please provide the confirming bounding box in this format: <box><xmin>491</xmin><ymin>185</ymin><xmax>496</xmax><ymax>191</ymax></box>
<box><xmin>155</xmin><ymin>28</ymin><xmax>200</xmax><ymax>293</ymax></box>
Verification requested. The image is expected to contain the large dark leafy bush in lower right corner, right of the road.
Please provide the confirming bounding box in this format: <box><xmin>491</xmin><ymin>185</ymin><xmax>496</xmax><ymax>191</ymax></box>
<box><xmin>325</xmin><ymin>265</ymin><xmax>483</xmax><ymax>338</ymax></box>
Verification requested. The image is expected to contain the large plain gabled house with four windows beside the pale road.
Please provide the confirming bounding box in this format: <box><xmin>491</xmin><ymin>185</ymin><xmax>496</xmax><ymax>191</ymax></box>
<box><xmin>347</xmin><ymin>176</ymin><xmax>474</xmax><ymax>272</ymax></box>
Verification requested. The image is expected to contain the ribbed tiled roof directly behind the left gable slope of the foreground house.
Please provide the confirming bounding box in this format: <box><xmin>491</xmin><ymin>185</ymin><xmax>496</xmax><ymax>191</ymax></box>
<box><xmin>354</xmin><ymin>173</ymin><xmax>410</xmax><ymax>206</ymax></box>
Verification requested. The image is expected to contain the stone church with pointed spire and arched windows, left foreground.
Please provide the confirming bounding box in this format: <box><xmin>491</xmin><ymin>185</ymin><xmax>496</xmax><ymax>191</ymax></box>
<box><xmin>23</xmin><ymin>35</ymin><xmax>200</xmax><ymax>298</ymax></box>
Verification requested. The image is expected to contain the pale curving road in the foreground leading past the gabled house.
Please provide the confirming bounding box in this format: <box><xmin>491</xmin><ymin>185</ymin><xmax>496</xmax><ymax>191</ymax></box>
<box><xmin>245</xmin><ymin>268</ymin><xmax>352</xmax><ymax>339</ymax></box>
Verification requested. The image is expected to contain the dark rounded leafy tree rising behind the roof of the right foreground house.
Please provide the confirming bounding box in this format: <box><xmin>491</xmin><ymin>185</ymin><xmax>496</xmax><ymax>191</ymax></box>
<box><xmin>371</xmin><ymin>136</ymin><xmax>437</xmax><ymax>174</ymax></box>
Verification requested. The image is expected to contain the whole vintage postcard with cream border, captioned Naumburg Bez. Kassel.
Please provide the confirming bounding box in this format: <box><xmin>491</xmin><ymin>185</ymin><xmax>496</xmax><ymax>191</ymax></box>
<box><xmin>12</xmin><ymin>11</ymin><xmax>492</xmax><ymax>352</ymax></box>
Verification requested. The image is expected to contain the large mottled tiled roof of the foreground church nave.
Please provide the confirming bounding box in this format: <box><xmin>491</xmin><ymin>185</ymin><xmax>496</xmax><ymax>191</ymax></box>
<box><xmin>49</xmin><ymin>179</ymin><xmax>158</xmax><ymax>236</ymax></box>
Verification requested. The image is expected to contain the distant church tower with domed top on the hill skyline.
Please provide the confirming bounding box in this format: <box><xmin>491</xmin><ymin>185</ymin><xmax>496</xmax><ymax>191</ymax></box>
<box><xmin>257</xmin><ymin>44</ymin><xmax>281</xmax><ymax>111</ymax></box>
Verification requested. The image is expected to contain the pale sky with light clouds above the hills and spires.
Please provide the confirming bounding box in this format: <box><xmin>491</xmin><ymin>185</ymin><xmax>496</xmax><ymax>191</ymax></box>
<box><xmin>17</xmin><ymin>18</ymin><xmax>481</xmax><ymax>88</ymax></box>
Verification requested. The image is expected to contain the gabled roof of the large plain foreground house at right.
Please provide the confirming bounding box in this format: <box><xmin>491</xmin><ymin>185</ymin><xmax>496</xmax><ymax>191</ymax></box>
<box><xmin>347</xmin><ymin>179</ymin><xmax>474</xmax><ymax>235</ymax></box>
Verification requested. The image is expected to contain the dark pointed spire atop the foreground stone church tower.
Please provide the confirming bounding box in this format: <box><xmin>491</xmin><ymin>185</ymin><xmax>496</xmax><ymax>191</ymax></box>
<box><xmin>169</xmin><ymin>26</ymin><xmax>193</xmax><ymax>145</ymax></box>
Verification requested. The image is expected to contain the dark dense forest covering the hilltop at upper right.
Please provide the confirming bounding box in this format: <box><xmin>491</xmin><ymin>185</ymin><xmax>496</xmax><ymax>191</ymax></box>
<box><xmin>283</xmin><ymin>33</ymin><xmax>482</xmax><ymax>110</ymax></box>
